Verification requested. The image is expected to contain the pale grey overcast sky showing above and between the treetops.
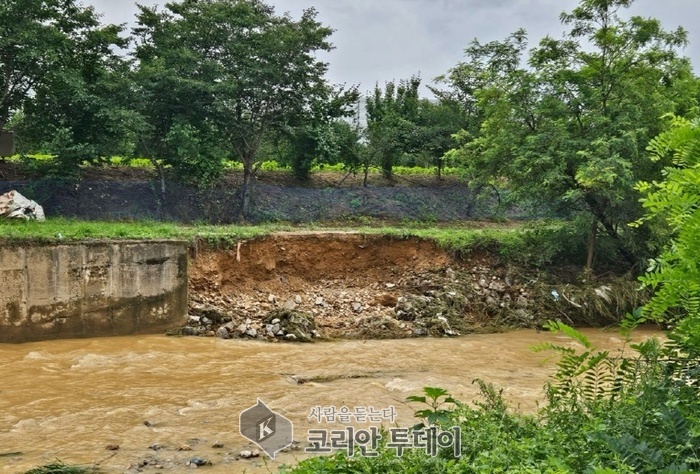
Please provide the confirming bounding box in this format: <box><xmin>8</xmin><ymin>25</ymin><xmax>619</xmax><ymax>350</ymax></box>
<box><xmin>83</xmin><ymin>0</ymin><xmax>700</xmax><ymax>96</ymax></box>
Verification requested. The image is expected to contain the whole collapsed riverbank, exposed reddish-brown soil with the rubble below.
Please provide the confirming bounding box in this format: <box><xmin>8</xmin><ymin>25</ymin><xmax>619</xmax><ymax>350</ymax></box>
<box><xmin>184</xmin><ymin>232</ymin><xmax>639</xmax><ymax>341</ymax></box>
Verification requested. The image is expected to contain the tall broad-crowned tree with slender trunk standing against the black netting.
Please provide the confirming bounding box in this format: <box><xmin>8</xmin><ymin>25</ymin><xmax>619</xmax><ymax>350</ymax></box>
<box><xmin>135</xmin><ymin>0</ymin><xmax>342</xmax><ymax>219</ymax></box>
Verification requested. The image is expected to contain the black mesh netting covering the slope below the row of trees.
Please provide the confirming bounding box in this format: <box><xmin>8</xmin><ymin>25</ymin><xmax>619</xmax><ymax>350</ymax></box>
<box><xmin>0</xmin><ymin>179</ymin><xmax>533</xmax><ymax>223</ymax></box>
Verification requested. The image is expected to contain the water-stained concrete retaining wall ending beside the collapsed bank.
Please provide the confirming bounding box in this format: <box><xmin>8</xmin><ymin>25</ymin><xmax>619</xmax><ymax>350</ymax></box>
<box><xmin>0</xmin><ymin>241</ymin><xmax>187</xmax><ymax>342</ymax></box>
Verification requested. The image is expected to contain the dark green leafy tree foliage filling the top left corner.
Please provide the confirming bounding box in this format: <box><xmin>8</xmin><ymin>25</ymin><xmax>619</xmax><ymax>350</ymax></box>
<box><xmin>0</xmin><ymin>0</ymin><xmax>139</xmax><ymax>173</ymax></box>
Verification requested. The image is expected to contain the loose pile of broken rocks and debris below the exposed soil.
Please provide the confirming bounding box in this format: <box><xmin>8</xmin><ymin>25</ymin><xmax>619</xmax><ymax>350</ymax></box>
<box><xmin>176</xmin><ymin>266</ymin><xmax>541</xmax><ymax>342</ymax></box>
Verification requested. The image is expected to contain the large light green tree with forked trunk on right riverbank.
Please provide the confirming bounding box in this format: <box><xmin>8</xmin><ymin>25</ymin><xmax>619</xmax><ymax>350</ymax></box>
<box><xmin>451</xmin><ymin>0</ymin><xmax>697</xmax><ymax>268</ymax></box>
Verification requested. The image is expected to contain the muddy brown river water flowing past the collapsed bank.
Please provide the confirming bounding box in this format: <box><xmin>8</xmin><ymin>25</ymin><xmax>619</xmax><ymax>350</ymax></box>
<box><xmin>0</xmin><ymin>328</ymin><xmax>661</xmax><ymax>474</ymax></box>
